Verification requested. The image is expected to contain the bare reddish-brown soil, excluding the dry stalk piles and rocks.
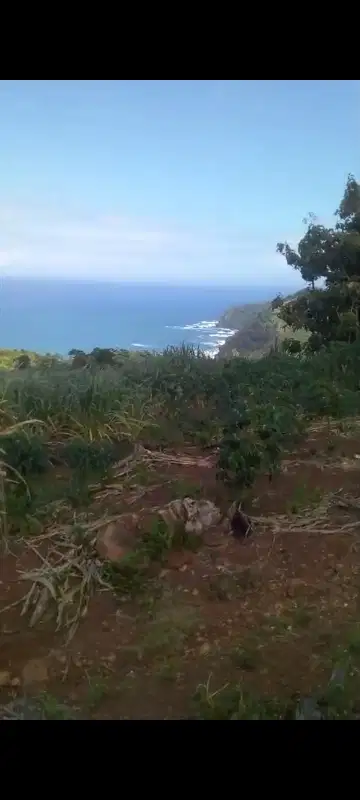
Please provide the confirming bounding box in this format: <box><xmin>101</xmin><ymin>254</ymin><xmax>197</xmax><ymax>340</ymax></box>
<box><xmin>0</xmin><ymin>428</ymin><xmax>360</xmax><ymax>719</ymax></box>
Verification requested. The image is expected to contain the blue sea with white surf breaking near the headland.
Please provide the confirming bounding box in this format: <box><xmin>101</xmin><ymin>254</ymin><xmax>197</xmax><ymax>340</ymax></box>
<box><xmin>0</xmin><ymin>278</ymin><xmax>292</xmax><ymax>355</ymax></box>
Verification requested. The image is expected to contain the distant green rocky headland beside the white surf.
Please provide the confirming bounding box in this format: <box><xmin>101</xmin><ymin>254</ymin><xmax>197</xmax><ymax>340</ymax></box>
<box><xmin>218</xmin><ymin>298</ymin><xmax>307</xmax><ymax>358</ymax></box>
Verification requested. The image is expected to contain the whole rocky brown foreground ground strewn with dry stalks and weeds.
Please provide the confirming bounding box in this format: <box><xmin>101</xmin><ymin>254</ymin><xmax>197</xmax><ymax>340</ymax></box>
<box><xmin>0</xmin><ymin>423</ymin><xmax>360</xmax><ymax>719</ymax></box>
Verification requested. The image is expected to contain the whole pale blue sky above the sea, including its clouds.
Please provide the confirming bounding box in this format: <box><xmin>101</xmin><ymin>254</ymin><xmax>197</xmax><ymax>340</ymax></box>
<box><xmin>0</xmin><ymin>80</ymin><xmax>360</xmax><ymax>286</ymax></box>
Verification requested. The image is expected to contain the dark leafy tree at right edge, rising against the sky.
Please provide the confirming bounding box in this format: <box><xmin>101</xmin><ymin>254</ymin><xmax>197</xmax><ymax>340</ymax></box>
<box><xmin>274</xmin><ymin>175</ymin><xmax>360</xmax><ymax>350</ymax></box>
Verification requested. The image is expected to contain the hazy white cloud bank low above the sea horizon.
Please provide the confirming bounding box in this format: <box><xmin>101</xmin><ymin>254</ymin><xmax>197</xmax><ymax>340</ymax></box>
<box><xmin>0</xmin><ymin>204</ymin><xmax>304</xmax><ymax>286</ymax></box>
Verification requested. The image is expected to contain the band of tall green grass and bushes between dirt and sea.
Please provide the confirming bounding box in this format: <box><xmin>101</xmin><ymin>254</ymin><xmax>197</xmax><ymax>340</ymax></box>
<box><xmin>0</xmin><ymin>342</ymin><xmax>360</xmax><ymax>504</ymax></box>
